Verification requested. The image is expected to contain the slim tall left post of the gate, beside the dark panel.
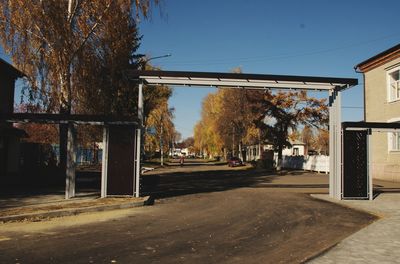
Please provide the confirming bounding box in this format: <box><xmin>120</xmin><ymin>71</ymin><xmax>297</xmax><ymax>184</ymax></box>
<box><xmin>134</xmin><ymin>83</ymin><xmax>143</xmax><ymax>197</ymax></box>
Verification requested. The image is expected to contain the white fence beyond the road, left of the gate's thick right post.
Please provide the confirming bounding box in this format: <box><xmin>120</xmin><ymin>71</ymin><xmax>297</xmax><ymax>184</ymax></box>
<box><xmin>274</xmin><ymin>155</ymin><xmax>329</xmax><ymax>173</ymax></box>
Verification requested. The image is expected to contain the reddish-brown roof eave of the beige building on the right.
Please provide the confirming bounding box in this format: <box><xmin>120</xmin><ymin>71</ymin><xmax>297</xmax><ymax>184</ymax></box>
<box><xmin>354</xmin><ymin>44</ymin><xmax>400</xmax><ymax>72</ymax></box>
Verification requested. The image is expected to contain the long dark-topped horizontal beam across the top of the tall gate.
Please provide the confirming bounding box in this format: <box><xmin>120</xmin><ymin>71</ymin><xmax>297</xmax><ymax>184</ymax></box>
<box><xmin>129</xmin><ymin>70</ymin><xmax>358</xmax><ymax>91</ymax></box>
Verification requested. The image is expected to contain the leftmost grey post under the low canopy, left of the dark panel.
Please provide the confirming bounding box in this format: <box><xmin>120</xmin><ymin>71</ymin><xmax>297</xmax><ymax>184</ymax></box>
<box><xmin>65</xmin><ymin>122</ymin><xmax>76</xmax><ymax>199</ymax></box>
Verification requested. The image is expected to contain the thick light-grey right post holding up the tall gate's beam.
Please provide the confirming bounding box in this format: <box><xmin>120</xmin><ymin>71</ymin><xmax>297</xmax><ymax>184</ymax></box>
<box><xmin>329</xmin><ymin>90</ymin><xmax>342</xmax><ymax>200</ymax></box>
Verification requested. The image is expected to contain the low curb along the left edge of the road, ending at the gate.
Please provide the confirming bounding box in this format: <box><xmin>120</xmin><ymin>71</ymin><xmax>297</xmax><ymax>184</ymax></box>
<box><xmin>0</xmin><ymin>196</ymin><xmax>152</xmax><ymax>223</ymax></box>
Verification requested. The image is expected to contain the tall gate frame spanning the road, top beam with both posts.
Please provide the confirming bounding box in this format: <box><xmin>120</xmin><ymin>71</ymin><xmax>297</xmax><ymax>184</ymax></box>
<box><xmin>132</xmin><ymin>70</ymin><xmax>358</xmax><ymax>200</ymax></box>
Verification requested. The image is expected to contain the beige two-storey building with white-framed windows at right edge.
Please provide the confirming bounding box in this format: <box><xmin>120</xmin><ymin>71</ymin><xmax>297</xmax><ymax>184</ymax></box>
<box><xmin>355</xmin><ymin>44</ymin><xmax>400</xmax><ymax>182</ymax></box>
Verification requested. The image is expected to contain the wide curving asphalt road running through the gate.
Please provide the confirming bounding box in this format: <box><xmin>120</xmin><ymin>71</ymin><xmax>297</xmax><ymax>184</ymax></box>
<box><xmin>0</xmin><ymin>166</ymin><xmax>375</xmax><ymax>263</ymax></box>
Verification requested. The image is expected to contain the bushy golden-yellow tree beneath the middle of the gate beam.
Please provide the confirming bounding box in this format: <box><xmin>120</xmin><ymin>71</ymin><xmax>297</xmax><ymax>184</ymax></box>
<box><xmin>194</xmin><ymin>89</ymin><xmax>260</xmax><ymax>158</ymax></box>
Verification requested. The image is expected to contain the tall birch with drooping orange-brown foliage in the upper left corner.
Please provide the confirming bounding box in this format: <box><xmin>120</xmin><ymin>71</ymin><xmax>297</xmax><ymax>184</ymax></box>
<box><xmin>0</xmin><ymin>0</ymin><xmax>158</xmax><ymax>171</ymax></box>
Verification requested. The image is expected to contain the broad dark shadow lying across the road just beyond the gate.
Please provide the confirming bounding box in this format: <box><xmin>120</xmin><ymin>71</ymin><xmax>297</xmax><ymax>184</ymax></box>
<box><xmin>142</xmin><ymin>166</ymin><xmax>329</xmax><ymax>199</ymax></box>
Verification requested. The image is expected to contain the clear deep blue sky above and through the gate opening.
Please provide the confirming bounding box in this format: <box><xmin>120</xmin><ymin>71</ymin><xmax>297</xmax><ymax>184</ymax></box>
<box><xmin>139</xmin><ymin>0</ymin><xmax>400</xmax><ymax>138</ymax></box>
